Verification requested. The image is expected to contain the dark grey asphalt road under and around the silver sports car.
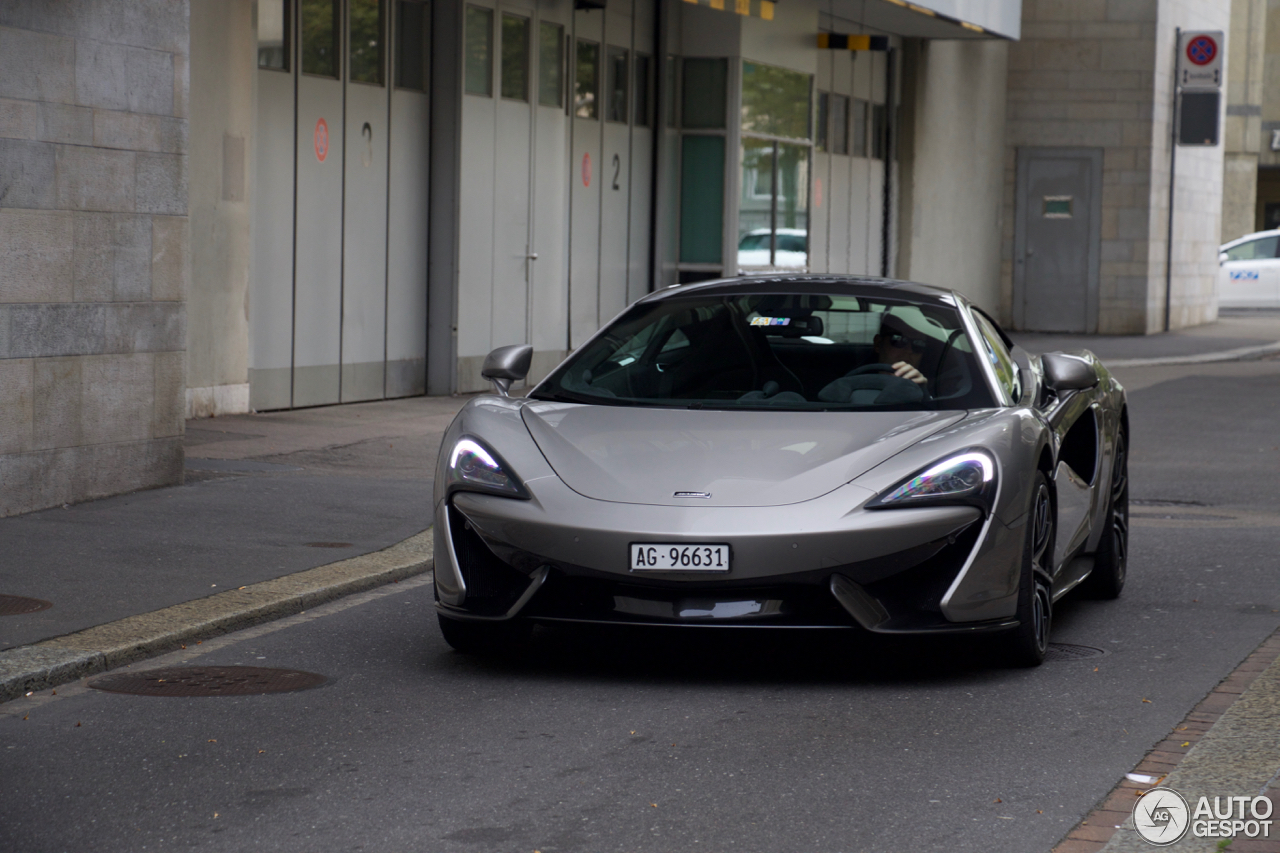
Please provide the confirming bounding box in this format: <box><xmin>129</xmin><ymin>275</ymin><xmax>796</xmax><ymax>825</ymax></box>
<box><xmin>0</xmin><ymin>361</ymin><xmax>1280</xmax><ymax>853</ymax></box>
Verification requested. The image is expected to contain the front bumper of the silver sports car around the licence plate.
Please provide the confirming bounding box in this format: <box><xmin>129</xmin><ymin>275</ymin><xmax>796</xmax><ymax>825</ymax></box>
<box><xmin>435</xmin><ymin>478</ymin><xmax>1021</xmax><ymax>633</ymax></box>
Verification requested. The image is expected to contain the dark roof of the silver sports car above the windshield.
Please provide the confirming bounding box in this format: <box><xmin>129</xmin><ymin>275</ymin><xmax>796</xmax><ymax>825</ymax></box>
<box><xmin>640</xmin><ymin>273</ymin><xmax>965</xmax><ymax>306</ymax></box>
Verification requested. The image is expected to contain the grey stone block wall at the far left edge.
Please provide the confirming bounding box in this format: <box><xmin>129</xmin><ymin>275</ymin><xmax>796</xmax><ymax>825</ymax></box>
<box><xmin>0</xmin><ymin>0</ymin><xmax>189</xmax><ymax>515</ymax></box>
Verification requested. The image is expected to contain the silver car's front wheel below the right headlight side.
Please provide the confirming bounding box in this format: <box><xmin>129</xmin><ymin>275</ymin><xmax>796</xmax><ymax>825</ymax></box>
<box><xmin>1005</xmin><ymin>471</ymin><xmax>1055</xmax><ymax>666</ymax></box>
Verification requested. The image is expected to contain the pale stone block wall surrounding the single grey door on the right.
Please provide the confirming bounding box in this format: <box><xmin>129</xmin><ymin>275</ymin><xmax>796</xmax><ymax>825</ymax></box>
<box><xmin>1001</xmin><ymin>0</ymin><xmax>1230</xmax><ymax>334</ymax></box>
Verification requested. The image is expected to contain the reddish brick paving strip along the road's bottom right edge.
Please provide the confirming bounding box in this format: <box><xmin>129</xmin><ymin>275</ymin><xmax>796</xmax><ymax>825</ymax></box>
<box><xmin>1052</xmin><ymin>630</ymin><xmax>1280</xmax><ymax>853</ymax></box>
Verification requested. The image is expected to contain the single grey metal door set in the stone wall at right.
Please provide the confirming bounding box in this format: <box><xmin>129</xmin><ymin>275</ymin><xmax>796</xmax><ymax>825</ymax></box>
<box><xmin>1014</xmin><ymin>149</ymin><xmax>1102</xmax><ymax>333</ymax></box>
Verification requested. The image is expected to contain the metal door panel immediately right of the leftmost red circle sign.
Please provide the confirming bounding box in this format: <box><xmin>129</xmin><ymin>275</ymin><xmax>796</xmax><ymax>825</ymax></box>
<box><xmin>340</xmin><ymin>0</ymin><xmax>389</xmax><ymax>402</ymax></box>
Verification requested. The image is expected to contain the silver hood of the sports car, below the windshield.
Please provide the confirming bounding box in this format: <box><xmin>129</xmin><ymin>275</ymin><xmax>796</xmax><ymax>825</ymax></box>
<box><xmin>522</xmin><ymin>402</ymin><xmax>965</xmax><ymax>506</ymax></box>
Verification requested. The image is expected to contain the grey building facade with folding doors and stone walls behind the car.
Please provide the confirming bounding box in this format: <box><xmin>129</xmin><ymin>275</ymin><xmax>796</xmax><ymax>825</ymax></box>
<box><xmin>0</xmin><ymin>0</ymin><xmax>1239</xmax><ymax>512</ymax></box>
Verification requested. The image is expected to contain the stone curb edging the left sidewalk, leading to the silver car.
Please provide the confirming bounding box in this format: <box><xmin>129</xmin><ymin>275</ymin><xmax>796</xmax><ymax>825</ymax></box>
<box><xmin>0</xmin><ymin>528</ymin><xmax>434</xmax><ymax>702</ymax></box>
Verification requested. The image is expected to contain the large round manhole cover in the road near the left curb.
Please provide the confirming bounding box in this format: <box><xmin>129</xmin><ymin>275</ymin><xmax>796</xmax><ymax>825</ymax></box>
<box><xmin>88</xmin><ymin>666</ymin><xmax>329</xmax><ymax>695</ymax></box>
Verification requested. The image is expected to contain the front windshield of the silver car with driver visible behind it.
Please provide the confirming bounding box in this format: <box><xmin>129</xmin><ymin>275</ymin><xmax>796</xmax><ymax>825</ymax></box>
<box><xmin>531</xmin><ymin>293</ymin><xmax>996</xmax><ymax>411</ymax></box>
